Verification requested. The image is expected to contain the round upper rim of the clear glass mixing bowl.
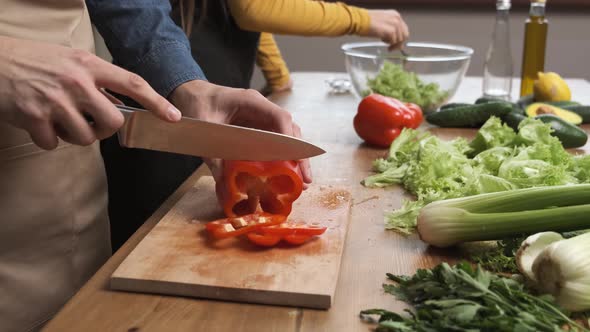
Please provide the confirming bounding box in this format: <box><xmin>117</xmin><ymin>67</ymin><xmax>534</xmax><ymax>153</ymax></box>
<box><xmin>340</xmin><ymin>42</ymin><xmax>473</xmax><ymax>62</ymax></box>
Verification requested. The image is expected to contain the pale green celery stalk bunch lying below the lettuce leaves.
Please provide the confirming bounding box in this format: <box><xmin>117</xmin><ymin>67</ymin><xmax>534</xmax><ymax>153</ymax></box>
<box><xmin>418</xmin><ymin>184</ymin><xmax>590</xmax><ymax>247</ymax></box>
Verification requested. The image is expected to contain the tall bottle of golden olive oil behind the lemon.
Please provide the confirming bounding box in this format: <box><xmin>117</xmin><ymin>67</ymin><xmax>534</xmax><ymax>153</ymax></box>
<box><xmin>520</xmin><ymin>0</ymin><xmax>548</xmax><ymax>97</ymax></box>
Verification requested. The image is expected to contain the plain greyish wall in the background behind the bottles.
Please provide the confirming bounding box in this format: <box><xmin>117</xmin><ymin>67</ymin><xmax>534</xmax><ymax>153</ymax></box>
<box><xmin>252</xmin><ymin>8</ymin><xmax>590</xmax><ymax>89</ymax></box>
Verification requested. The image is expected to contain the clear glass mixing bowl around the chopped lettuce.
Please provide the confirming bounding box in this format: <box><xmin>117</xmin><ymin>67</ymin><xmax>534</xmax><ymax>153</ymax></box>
<box><xmin>342</xmin><ymin>42</ymin><xmax>473</xmax><ymax>113</ymax></box>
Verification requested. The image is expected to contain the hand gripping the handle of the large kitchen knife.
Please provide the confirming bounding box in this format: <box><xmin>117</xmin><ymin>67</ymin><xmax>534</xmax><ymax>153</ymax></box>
<box><xmin>0</xmin><ymin>36</ymin><xmax>181</xmax><ymax>150</ymax></box>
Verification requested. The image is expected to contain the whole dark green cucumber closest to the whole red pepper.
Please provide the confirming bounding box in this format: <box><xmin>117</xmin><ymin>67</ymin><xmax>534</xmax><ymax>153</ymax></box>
<box><xmin>426</xmin><ymin>102</ymin><xmax>512</xmax><ymax>128</ymax></box>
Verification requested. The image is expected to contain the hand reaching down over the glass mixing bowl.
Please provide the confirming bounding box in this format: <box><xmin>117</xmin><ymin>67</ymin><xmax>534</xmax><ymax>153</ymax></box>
<box><xmin>368</xmin><ymin>10</ymin><xmax>410</xmax><ymax>50</ymax></box>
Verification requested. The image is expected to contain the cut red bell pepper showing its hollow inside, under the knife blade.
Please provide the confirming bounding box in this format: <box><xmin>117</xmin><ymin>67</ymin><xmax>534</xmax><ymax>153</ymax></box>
<box><xmin>216</xmin><ymin>160</ymin><xmax>303</xmax><ymax>217</ymax></box>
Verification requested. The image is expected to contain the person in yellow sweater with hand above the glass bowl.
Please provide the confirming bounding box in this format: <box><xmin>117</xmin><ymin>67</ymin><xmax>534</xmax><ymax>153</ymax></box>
<box><xmin>180</xmin><ymin>0</ymin><xmax>409</xmax><ymax>91</ymax></box>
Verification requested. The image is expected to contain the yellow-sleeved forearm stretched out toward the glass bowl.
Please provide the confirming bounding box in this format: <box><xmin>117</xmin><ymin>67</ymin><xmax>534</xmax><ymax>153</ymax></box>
<box><xmin>228</xmin><ymin>0</ymin><xmax>370</xmax><ymax>36</ymax></box>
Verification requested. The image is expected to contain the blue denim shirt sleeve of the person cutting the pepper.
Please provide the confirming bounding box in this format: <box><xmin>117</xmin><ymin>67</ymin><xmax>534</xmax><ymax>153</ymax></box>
<box><xmin>86</xmin><ymin>0</ymin><xmax>205</xmax><ymax>97</ymax></box>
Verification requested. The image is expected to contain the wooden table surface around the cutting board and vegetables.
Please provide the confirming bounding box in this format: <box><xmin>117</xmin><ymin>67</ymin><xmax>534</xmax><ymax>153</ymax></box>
<box><xmin>45</xmin><ymin>73</ymin><xmax>590</xmax><ymax>332</ymax></box>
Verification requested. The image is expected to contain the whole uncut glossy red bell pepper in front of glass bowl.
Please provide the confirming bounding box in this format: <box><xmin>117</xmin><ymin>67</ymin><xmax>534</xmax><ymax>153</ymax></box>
<box><xmin>354</xmin><ymin>94</ymin><xmax>423</xmax><ymax>148</ymax></box>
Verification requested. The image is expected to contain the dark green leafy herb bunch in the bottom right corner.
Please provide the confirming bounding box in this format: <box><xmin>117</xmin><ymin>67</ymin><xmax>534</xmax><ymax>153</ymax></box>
<box><xmin>361</xmin><ymin>263</ymin><xmax>588</xmax><ymax>332</ymax></box>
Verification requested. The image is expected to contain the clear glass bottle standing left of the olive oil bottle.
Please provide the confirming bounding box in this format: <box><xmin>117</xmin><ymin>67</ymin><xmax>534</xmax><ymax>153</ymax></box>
<box><xmin>483</xmin><ymin>0</ymin><xmax>513</xmax><ymax>100</ymax></box>
